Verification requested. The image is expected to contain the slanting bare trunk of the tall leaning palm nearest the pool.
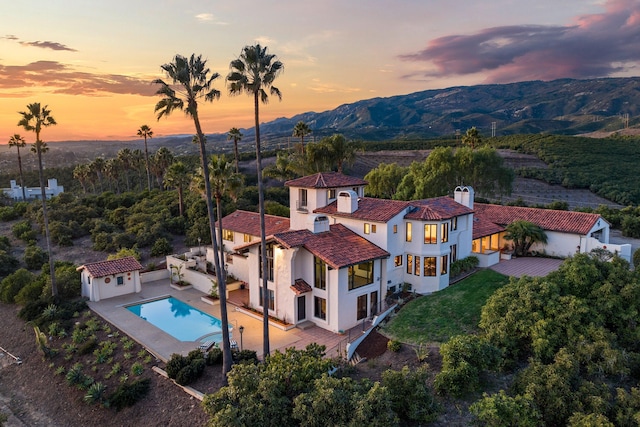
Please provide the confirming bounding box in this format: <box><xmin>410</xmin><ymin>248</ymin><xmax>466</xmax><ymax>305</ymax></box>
<box><xmin>193</xmin><ymin>112</ymin><xmax>233</xmax><ymax>384</ymax></box>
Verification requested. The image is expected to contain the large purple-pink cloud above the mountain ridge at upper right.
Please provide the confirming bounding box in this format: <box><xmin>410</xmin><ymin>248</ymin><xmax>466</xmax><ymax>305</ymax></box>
<box><xmin>401</xmin><ymin>0</ymin><xmax>640</xmax><ymax>83</ymax></box>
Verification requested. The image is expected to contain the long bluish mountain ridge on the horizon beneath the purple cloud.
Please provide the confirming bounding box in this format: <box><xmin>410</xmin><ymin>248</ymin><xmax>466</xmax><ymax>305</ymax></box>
<box><xmin>261</xmin><ymin>77</ymin><xmax>640</xmax><ymax>140</ymax></box>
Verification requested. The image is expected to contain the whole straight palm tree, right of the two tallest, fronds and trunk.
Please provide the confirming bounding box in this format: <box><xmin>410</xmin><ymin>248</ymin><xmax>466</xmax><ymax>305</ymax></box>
<box><xmin>227</xmin><ymin>43</ymin><xmax>284</xmax><ymax>357</ymax></box>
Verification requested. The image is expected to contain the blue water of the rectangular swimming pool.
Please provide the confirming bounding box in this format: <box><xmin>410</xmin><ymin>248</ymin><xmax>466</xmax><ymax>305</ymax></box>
<box><xmin>127</xmin><ymin>297</ymin><xmax>228</xmax><ymax>342</ymax></box>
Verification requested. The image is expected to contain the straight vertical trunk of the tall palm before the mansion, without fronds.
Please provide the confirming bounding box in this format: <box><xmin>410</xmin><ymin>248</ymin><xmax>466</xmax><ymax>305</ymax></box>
<box><xmin>253</xmin><ymin>92</ymin><xmax>270</xmax><ymax>358</ymax></box>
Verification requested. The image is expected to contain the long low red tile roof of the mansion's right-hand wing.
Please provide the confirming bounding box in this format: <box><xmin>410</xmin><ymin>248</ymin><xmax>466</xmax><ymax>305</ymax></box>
<box><xmin>473</xmin><ymin>203</ymin><xmax>605</xmax><ymax>235</ymax></box>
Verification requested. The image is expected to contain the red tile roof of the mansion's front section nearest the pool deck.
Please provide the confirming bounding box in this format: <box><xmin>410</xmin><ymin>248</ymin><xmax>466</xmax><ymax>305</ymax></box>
<box><xmin>274</xmin><ymin>224</ymin><xmax>389</xmax><ymax>268</ymax></box>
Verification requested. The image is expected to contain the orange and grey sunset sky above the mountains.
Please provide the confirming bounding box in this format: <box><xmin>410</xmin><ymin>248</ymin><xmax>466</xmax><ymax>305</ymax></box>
<box><xmin>0</xmin><ymin>0</ymin><xmax>640</xmax><ymax>143</ymax></box>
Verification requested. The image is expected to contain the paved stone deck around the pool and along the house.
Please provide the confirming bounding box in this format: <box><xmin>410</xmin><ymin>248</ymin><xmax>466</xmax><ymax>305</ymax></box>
<box><xmin>88</xmin><ymin>280</ymin><xmax>350</xmax><ymax>361</ymax></box>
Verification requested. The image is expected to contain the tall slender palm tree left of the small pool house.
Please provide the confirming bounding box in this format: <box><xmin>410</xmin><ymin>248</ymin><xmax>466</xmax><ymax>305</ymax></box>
<box><xmin>18</xmin><ymin>102</ymin><xmax>58</xmax><ymax>298</ymax></box>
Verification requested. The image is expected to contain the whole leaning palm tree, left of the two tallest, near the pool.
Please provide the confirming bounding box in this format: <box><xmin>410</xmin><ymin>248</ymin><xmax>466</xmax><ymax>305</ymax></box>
<box><xmin>154</xmin><ymin>54</ymin><xmax>232</xmax><ymax>379</ymax></box>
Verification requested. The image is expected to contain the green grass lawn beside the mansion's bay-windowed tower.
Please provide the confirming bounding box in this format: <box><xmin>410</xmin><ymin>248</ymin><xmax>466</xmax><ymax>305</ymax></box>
<box><xmin>383</xmin><ymin>270</ymin><xmax>509</xmax><ymax>344</ymax></box>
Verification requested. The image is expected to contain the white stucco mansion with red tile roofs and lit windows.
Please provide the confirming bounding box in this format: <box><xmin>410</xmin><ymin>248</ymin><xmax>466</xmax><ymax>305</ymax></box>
<box><xmin>216</xmin><ymin>172</ymin><xmax>630</xmax><ymax>332</ymax></box>
